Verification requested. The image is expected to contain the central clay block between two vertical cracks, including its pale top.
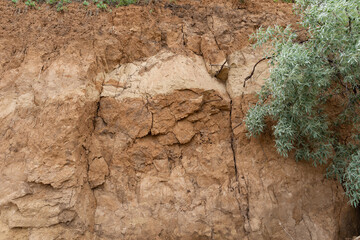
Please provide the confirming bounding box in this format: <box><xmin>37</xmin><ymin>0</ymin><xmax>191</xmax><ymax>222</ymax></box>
<box><xmin>89</xmin><ymin>53</ymin><xmax>244</xmax><ymax>239</ymax></box>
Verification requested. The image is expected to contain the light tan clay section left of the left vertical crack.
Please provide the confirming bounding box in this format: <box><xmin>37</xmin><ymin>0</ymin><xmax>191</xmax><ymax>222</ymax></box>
<box><xmin>0</xmin><ymin>39</ymin><xmax>98</xmax><ymax>239</ymax></box>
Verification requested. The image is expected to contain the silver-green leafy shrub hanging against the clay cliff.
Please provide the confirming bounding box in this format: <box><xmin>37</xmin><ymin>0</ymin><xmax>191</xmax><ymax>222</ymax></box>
<box><xmin>245</xmin><ymin>0</ymin><xmax>360</xmax><ymax>207</ymax></box>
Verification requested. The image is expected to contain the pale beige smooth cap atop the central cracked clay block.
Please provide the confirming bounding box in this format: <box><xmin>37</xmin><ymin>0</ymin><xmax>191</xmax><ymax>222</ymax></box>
<box><xmin>98</xmin><ymin>51</ymin><xmax>226</xmax><ymax>99</ymax></box>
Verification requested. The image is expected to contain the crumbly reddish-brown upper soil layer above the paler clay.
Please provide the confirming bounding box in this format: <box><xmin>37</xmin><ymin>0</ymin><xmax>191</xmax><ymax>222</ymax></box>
<box><xmin>0</xmin><ymin>0</ymin><xmax>296</xmax><ymax>77</ymax></box>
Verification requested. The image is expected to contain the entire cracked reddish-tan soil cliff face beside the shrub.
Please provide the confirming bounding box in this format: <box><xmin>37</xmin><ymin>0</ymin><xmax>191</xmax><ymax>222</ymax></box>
<box><xmin>0</xmin><ymin>0</ymin><xmax>359</xmax><ymax>240</ymax></box>
